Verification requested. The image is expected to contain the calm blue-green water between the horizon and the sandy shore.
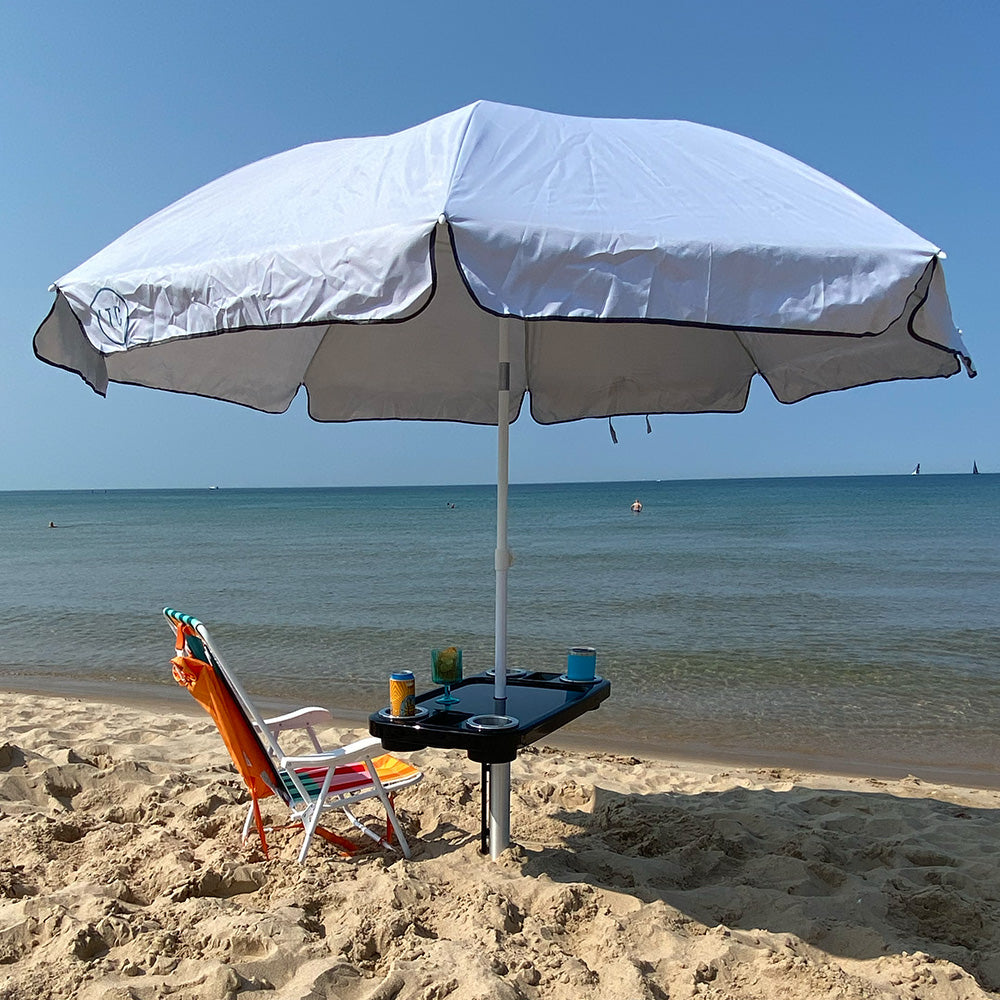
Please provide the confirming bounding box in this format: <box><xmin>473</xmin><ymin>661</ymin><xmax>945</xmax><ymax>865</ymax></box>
<box><xmin>0</xmin><ymin>475</ymin><xmax>1000</xmax><ymax>783</ymax></box>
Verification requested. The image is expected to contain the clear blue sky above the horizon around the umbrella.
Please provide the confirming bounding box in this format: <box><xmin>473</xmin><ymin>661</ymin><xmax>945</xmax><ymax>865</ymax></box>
<box><xmin>0</xmin><ymin>0</ymin><xmax>1000</xmax><ymax>489</ymax></box>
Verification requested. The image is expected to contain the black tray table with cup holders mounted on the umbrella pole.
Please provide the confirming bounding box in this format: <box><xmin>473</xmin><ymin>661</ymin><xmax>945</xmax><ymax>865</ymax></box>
<box><xmin>368</xmin><ymin>671</ymin><xmax>611</xmax><ymax>854</ymax></box>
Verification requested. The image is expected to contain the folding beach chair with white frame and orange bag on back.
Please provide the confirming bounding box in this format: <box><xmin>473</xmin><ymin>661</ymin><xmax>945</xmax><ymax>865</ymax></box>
<box><xmin>163</xmin><ymin>608</ymin><xmax>423</xmax><ymax>864</ymax></box>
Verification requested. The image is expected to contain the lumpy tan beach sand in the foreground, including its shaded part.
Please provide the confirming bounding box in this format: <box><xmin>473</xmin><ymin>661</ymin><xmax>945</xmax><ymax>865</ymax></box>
<box><xmin>0</xmin><ymin>692</ymin><xmax>1000</xmax><ymax>1000</ymax></box>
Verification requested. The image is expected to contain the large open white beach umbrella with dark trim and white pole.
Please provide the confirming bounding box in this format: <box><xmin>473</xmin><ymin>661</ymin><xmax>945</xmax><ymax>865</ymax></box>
<box><xmin>34</xmin><ymin>101</ymin><xmax>974</xmax><ymax>852</ymax></box>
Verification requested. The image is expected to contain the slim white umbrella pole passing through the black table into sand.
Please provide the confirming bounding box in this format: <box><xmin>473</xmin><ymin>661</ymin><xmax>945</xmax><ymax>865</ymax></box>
<box><xmin>489</xmin><ymin>318</ymin><xmax>513</xmax><ymax>861</ymax></box>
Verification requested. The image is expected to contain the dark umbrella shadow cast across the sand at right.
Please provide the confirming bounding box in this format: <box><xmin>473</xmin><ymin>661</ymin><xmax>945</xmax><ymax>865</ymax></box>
<box><xmin>523</xmin><ymin>787</ymin><xmax>1000</xmax><ymax>990</ymax></box>
